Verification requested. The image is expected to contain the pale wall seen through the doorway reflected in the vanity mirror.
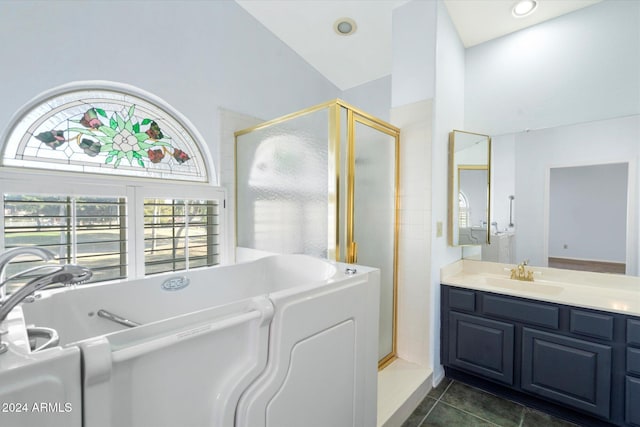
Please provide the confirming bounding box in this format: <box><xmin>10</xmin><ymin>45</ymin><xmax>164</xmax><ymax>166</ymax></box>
<box><xmin>549</xmin><ymin>163</ymin><xmax>629</xmax><ymax>264</ymax></box>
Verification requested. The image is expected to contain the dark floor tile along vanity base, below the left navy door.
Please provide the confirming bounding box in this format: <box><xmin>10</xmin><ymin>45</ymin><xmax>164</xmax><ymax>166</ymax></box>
<box><xmin>440</xmin><ymin>381</ymin><xmax>524</xmax><ymax>427</ymax></box>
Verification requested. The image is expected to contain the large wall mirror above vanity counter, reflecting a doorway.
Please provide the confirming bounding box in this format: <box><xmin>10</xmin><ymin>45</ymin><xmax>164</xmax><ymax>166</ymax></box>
<box><xmin>463</xmin><ymin>116</ymin><xmax>640</xmax><ymax>276</ymax></box>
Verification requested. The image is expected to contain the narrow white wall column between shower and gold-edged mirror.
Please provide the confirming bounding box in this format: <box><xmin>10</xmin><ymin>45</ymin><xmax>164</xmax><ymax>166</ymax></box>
<box><xmin>384</xmin><ymin>0</ymin><xmax>465</xmax><ymax>402</ymax></box>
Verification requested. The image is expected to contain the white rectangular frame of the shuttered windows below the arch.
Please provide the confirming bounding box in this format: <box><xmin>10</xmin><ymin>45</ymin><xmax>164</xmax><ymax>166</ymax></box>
<box><xmin>0</xmin><ymin>167</ymin><xmax>230</xmax><ymax>283</ymax></box>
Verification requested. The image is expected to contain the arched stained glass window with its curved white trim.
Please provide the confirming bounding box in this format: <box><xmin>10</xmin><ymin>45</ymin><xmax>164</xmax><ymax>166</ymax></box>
<box><xmin>0</xmin><ymin>81</ymin><xmax>215</xmax><ymax>182</ymax></box>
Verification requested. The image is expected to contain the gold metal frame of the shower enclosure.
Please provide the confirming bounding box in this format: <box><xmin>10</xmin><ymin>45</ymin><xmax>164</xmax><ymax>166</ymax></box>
<box><xmin>234</xmin><ymin>99</ymin><xmax>400</xmax><ymax>369</ymax></box>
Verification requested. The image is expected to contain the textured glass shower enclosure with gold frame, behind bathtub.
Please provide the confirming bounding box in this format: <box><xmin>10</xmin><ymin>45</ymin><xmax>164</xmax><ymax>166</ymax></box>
<box><xmin>235</xmin><ymin>99</ymin><xmax>400</xmax><ymax>367</ymax></box>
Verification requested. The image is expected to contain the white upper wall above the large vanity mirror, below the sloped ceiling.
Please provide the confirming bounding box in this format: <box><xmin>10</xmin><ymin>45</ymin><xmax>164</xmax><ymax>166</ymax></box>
<box><xmin>465</xmin><ymin>0</ymin><xmax>640</xmax><ymax>135</ymax></box>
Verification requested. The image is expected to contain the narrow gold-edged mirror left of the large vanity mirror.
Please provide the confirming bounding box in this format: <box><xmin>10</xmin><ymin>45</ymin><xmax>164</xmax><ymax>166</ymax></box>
<box><xmin>449</xmin><ymin>130</ymin><xmax>491</xmax><ymax>246</ymax></box>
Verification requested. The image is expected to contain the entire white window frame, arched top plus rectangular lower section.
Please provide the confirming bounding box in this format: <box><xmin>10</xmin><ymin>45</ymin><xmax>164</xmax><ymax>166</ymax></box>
<box><xmin>0</xmin><ymin>80</ymin><xmax>226</xmax><ymax>283</ymax></box>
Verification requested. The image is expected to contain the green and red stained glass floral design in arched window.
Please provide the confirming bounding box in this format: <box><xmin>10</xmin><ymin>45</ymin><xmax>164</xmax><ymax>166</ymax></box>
<box><xmin>35</xmin><ymin>105</ymin><xmax>190</xmax><ymax>168</ymax></box>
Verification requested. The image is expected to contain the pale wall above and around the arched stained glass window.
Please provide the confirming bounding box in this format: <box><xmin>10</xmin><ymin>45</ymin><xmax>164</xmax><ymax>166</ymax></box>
<box><xmin>0</xmin><ymin>0</ymin><xmax>340</xmax><ymax>182</ymax></box>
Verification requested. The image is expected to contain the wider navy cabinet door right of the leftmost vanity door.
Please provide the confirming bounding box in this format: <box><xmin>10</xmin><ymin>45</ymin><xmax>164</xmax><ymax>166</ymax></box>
<box><xmin>522</xmin><ymin>328</ymin><xmax>611</xmax><ymax>418</ymax></box>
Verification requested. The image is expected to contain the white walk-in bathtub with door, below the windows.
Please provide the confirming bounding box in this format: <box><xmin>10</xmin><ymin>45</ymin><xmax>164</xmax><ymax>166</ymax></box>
<box><xmin>16</xmin><ymin>255</ymin><xmax>379</xmax><ymax>427</ymax></box>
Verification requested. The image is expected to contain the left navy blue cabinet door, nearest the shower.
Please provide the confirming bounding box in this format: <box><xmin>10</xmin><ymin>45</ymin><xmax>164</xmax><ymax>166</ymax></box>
<box><xmin>447</xmin><ymin>312</ymin><xmax>514</xmax><ymax>385</ymax></box>
